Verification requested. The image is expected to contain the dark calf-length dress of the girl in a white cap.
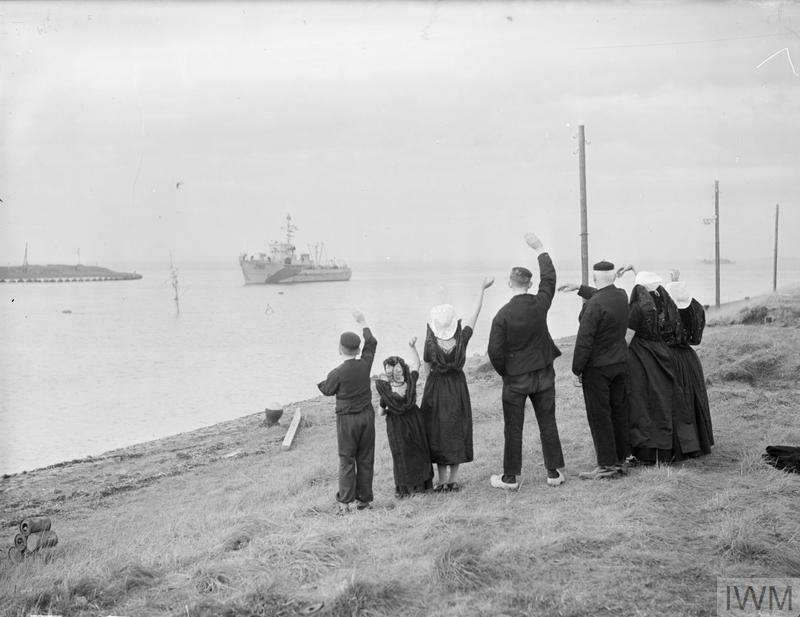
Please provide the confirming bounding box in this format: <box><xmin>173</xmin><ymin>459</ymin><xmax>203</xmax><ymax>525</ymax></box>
<box><xmin>420</xmin><ymin>319</ymin><xmax>472</xmax><ymax>465</ymax></box>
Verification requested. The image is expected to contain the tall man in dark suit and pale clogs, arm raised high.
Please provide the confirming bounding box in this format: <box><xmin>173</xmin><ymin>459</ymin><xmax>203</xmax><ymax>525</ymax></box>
<box><xmin>489</xmin><ymin>233</ymin><xmax>565</xmax><ymax>489</ymax></box>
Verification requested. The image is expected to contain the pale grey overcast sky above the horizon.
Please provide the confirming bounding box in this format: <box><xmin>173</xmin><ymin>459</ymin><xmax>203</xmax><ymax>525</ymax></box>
<box><xmin>0</xmin><ymin>2</ymin><xmax>800</xmax><ymax>265</ymax></box>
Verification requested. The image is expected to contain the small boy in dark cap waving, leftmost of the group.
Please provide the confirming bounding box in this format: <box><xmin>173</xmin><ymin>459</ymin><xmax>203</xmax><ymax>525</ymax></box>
<box><xmin>317</xmin><ymin>311</ymin><xmax>378</xmax><ymax>513</ymax></box>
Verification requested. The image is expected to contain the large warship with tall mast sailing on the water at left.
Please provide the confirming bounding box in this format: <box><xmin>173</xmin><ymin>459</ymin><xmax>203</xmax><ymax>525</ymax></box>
<box><xmin>239</xmin><ymin>214</ymin><xmax>352</xmax><ymax>285</ymax></box>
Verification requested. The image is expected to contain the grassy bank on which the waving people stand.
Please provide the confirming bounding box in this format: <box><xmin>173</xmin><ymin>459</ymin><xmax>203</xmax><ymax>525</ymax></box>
<box><xmin>0</xmin><ymin>292</ymin><xmax>800</xmax><ymax>617</ymax></box>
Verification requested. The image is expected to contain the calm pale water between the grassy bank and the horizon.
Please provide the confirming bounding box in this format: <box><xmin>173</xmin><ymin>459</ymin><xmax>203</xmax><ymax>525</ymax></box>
<box><xmin>0</xmin><ymin>261</ymin><xmax>800</xmax><ymax>473</ymax></box>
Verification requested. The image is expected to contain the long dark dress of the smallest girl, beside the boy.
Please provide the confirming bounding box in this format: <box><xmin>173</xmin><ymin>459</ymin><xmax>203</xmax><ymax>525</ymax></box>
<box><xmin>375</xmin><ymin>357</ymin><xmax>433</xmax><ymax>497</ymax></box>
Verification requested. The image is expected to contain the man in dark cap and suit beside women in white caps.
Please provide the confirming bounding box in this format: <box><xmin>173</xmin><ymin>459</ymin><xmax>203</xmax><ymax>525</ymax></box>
<box><xmin>560</xmin><ymin>261</ymin><xmax>630</xmax><ymax>480</ymax></box>
